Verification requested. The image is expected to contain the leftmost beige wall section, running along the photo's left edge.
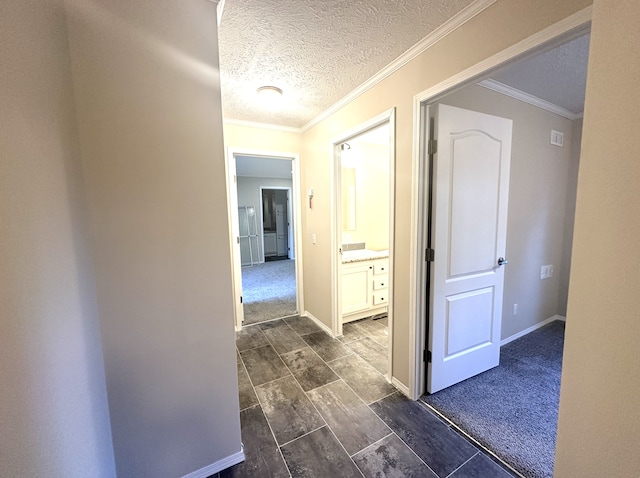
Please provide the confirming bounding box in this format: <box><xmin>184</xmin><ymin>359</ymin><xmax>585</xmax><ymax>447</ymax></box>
<box><xmin>0</xmin><ymin>0</ymin><xmax>115</xmax><ymax>478</ymax></box>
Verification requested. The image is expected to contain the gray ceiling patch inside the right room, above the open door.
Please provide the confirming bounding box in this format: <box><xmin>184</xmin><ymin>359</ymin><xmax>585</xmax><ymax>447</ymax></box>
<box><xmin>491</xmin><ymin>34</ymin><xmax>589</xmax><ymax>113</ymax></box>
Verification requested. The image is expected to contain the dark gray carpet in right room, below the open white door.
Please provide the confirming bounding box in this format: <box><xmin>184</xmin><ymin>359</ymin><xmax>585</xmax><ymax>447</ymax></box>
<box><xmin>422</xmin><ymin>321</ymin><xmax>564</xmax><ymax>478</ymax></box>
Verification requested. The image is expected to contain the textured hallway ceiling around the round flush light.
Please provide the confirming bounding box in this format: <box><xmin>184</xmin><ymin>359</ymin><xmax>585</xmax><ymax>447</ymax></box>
<box><xmin>219</xmin><ymin>0</ymin><xmax>472</xmax><ymax>128</ymax></box>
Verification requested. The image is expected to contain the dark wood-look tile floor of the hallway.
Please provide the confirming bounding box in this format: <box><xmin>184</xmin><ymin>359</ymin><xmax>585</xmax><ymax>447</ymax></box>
<box><xmin>214</xmin><ymin>317</ymin><xmax>513</xmax><ymax>478</ymax></box>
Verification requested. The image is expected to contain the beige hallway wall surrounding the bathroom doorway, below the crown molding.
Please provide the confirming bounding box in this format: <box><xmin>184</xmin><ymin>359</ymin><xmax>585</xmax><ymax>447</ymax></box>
<box><xmin>302</xmin><ymin>0</ymin><xmax>591</xmax><ymax>385</ymax></box>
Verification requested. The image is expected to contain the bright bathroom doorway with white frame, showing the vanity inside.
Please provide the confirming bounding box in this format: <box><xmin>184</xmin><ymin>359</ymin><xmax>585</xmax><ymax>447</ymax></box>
<box><xmin>332</xmin><ymin>110</ymin><xmax>395</xmax><ymax>381</ymax></box>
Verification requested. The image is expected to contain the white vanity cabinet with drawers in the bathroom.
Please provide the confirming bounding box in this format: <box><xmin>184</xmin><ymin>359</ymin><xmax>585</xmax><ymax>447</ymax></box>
<box><xmin>342</xmin><ymin>258</ymin><xmax>389</xmax><ymax>322</ymax></box>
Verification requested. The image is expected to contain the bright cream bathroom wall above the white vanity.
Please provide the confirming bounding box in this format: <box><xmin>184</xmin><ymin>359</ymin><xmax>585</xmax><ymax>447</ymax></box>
<box><xmin>342</xmin><ymin>142</ymin><xmax>389</xmax><ymax>251</ymax></box>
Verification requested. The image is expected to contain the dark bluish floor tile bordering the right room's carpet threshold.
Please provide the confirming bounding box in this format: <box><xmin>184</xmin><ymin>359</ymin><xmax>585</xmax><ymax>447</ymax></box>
<box><xmin>371</xmin><ymin>393</ymin><xmax>478</xmax><ymax>476</ymax></box>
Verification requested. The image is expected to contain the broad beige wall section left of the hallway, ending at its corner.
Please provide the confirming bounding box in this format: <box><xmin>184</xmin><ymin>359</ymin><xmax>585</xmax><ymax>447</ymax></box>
<box><xmin>68</xmin><ymin>0</ymin><xmax>241</xmax><ymax>477</ymax></box>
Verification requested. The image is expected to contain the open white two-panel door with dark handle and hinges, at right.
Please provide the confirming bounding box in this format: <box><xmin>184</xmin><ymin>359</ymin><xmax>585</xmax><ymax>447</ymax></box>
<box><xmin>427</xmin><ymin>104</ymin><xmax>512</xmax><ymax>393</ymax></box>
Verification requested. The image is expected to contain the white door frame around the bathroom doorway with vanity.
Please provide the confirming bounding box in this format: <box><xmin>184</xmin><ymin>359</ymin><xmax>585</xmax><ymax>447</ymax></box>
<box><xmin>331</xmin><ymin>108</ymin><xmax>396</xmax><ymax>382</ymax></box>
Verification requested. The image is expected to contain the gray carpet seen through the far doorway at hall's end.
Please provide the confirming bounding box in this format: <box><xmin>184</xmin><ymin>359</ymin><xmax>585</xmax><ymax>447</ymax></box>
<box><xmin>242</xmin><ymin>260</ymin><xmax>296</xmax><ymax>325</ymax></box>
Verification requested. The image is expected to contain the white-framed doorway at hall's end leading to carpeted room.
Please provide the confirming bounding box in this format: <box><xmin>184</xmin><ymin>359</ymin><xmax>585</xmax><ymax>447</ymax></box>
<box><xmin>227</xmin><ymin>149</ymin><xmax>304</xmax><ymax>331</ymax></box>
